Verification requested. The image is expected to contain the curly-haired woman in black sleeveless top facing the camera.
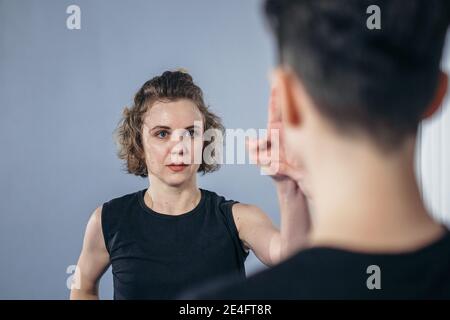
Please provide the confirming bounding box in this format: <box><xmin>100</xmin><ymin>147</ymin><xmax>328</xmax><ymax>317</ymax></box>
<box><xmin>71</xmin><ymin>71</ymin><xmax>309</xmax><ymax>299</ymax></box>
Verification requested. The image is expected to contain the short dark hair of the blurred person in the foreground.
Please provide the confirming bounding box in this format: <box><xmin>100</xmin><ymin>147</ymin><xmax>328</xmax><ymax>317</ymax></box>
<box><xmin>265</xmin><ymin>0</ymin><xmax>450</xmax><ymax>147</ymax></box>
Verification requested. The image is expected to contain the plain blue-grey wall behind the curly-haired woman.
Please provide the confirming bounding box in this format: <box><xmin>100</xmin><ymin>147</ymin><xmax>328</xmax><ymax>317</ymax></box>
<box><xmin>0</xmin><ymin>0</ymin><xmax>279</xmax><ymax>299</ymax></box>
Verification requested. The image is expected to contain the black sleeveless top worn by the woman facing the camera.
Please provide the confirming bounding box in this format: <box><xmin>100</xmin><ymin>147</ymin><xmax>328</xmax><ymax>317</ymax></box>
<box><xmin>102</xmin><ymin>189</ymin><xmax>248</xmax><ymax>299</ymax></box>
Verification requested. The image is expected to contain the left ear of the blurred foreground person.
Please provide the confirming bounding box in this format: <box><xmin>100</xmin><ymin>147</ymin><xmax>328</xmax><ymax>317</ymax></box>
<box><xmin>272</xmin><ymin>67</ymin><xmax>301</xmax><ymax>127</ymax></box>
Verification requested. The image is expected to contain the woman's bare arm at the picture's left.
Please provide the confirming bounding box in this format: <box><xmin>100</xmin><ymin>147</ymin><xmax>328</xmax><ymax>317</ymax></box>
<box><xmin>72</xmin><ymin>206</ymin><xmax>110</xmax><ymax>294</ymax></box>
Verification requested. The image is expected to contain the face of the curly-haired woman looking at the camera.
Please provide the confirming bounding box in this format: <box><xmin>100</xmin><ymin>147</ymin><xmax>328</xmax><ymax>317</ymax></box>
<box><xmin>142</xmin><ymin>99</ymin><xmax>203</xmax><ymax>186</ymax></box>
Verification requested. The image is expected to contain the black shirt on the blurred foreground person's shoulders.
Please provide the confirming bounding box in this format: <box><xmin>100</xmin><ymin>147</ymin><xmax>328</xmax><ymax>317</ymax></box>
<box><xmin>195</xmin><ymin>226</ymin><xmax>450</xmax><ymax>300</ymax></box>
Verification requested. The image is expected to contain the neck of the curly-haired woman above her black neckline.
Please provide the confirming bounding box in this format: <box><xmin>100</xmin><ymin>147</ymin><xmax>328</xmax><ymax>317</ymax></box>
<box><xmin>144</xmin><ymin>177</ymin><xmax>201</xmax><ymax>215</ymax></box>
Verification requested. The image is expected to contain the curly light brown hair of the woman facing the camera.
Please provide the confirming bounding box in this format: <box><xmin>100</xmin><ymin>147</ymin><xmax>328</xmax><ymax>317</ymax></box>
<box><xmin>114</xmin><ymin>70</ymin><xmax>225</xmax><ymax>178</ymax></box>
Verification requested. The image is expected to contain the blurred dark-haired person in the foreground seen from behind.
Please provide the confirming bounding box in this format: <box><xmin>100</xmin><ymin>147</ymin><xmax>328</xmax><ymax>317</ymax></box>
<box><xmin>190</xmin><ymin>0</ymin><xmax>450</xmax><ymax>299</ymax></box>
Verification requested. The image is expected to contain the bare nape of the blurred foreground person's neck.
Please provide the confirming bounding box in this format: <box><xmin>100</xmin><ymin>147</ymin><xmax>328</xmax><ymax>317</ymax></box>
<box><xmin>310</xmin><ymin>138</ymin><xmax>445</xmax><ymax>253</ymax></box>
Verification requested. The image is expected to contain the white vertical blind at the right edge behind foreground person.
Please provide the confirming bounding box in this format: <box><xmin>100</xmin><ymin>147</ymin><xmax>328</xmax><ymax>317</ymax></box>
<box><xmin>416</xmin><ymin>37</ymin><xmax>450</xmax><ymax>226</ymax></box>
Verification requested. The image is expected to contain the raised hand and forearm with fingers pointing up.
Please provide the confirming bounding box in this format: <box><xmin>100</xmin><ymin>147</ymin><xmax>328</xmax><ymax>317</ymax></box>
<box><xmin>247</xmin><ymin>86</ymin><xmax>311</xmax><ymax>257</ymax></box>
